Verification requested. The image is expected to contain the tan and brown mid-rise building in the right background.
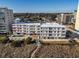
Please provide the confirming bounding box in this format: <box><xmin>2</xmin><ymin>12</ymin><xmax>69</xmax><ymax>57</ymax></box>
<box><xmin>57</xmin><ymin>12</ymin><xmax>75</xmax><ymax>24</ymax></box>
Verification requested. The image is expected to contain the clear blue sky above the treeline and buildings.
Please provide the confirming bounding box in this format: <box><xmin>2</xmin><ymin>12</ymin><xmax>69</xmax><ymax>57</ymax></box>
<box><xmin>0</xmin><ymin>0</ymin><xmax>78</xmax><ymax>13</ymax></box>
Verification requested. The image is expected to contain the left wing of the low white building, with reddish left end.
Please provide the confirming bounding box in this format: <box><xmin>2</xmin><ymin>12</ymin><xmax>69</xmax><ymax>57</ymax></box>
<box><xmin>12</xmin><ymin>23</ymin><xmax>40</xmax><ymax>35</ymax></box>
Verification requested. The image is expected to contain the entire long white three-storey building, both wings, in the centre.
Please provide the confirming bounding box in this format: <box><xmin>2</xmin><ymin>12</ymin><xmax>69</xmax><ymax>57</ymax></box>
<box><xmin>12</xmin><ymin>23</ymin><xmax>66</xmax><ymax>39</ymax></box>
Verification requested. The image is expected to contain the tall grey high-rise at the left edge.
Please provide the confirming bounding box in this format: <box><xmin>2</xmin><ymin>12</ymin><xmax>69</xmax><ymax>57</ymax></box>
<box><xmin>0</xmin><ymin>8</ymin><xmax>13</xmax><ymax>33</ymax></box>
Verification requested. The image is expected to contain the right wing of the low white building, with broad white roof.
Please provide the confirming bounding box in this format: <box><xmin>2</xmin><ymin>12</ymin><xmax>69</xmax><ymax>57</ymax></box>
<box><xmin>40</xmin><ymin>23</ymin><xmax>66</xmax><ymax>39</ymax></box>
